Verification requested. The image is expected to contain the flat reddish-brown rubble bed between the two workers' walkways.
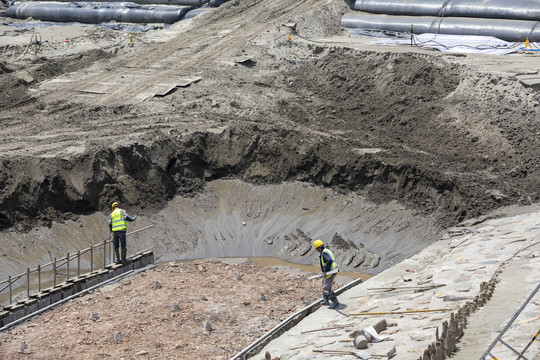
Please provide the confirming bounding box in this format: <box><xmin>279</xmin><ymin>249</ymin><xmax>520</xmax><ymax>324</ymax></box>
<box><xmin>0</xmin><ymin>260</ymin><xmax>320</xmax><ymax>360</ymax></box>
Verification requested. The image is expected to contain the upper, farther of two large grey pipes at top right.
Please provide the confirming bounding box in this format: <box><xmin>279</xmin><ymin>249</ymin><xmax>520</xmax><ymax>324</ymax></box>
<box><xmin>350</xmin><ymin>0</ymin><xmax>540</xmax><ymax>20</ymax></box>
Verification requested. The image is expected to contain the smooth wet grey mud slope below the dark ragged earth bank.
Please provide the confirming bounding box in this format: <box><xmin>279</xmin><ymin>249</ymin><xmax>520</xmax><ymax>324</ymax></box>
<box><xmin>0</xmin><ymin>176</ymin><xmax>437</xmax><ymax>277</ymax></box>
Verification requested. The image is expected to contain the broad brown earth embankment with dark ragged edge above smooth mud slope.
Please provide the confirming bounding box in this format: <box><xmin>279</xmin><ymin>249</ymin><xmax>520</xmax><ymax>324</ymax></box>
<box><xmin>0</xmin><ymin>0</ymin><xmax>540</xmax><ymax>278</ymax></box>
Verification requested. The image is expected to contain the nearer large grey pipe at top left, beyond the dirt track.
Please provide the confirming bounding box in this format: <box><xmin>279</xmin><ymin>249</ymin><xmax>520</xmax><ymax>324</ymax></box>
<box><xmin>6</xmin><ymin>2</ymin><xmax>192</xmax><ymax>24</ymax></box>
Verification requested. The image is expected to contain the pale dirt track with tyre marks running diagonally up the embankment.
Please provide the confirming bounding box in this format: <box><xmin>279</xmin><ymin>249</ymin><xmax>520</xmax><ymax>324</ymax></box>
<box><xmin>19</xmin><ymin>0</ymin><xmax>324</xmax><ymax>106</ymax></box>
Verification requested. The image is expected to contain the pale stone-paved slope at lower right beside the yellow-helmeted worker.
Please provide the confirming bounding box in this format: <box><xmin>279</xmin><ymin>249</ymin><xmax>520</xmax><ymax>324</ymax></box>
<box><xmin>253</xmin><ymin>210</ymin><xmax>540</xmax><ymax>360</ymax></box>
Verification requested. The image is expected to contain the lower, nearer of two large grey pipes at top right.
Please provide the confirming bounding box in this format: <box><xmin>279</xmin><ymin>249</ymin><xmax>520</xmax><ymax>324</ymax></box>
<box><xmin>341</xmin><ymin>11</ymin><xmax>540</xmax><ymax>42</ymax></box>
